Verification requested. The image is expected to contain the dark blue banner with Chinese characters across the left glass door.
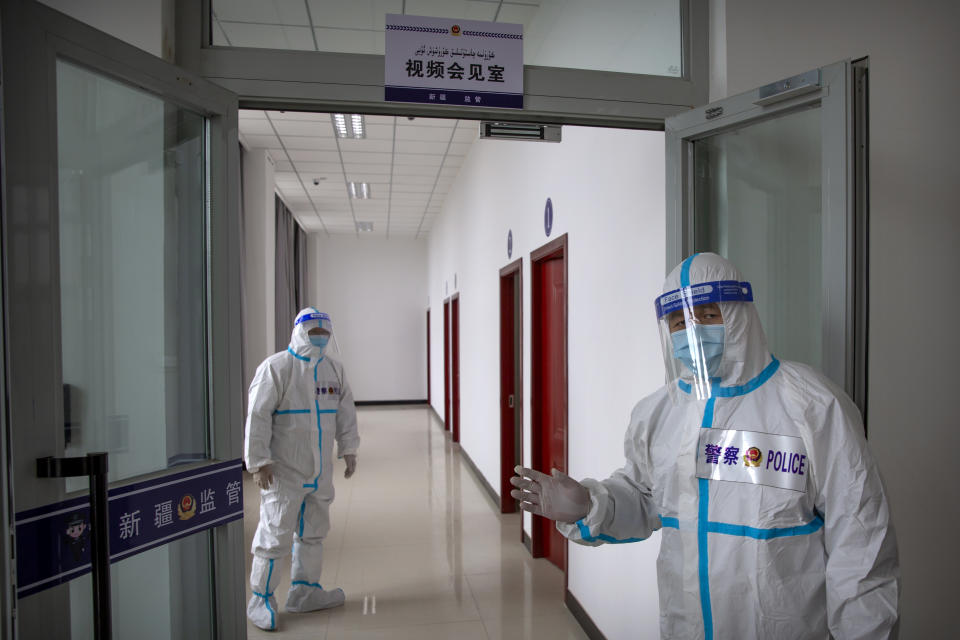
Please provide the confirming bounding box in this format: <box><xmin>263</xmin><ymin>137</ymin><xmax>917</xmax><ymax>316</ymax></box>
<box><xmin>15</xmin><ymin>459</ymin><xmax>243</xmax><ymax>598</ymax></box>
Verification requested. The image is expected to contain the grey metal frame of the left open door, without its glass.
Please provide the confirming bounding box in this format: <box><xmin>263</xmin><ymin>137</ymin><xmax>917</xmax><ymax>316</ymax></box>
<box><xmin>0</xmin><ymin>0</ymin><xmax>246</xmax><ymax>638</ymax></box>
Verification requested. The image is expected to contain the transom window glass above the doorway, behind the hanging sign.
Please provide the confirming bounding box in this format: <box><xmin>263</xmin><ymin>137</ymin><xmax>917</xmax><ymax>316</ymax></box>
<box><xmin>211</xmin><ymin>0</ymin><xmax>683</xmax><ymax>77</ymax></box>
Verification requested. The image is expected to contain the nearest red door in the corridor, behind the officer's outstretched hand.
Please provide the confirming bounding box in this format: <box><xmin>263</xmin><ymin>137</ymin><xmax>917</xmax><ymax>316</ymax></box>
<box><xmin>531</xmin><ymin>235</ymin><xmax>567</xmax><ymax>570</ymax></box>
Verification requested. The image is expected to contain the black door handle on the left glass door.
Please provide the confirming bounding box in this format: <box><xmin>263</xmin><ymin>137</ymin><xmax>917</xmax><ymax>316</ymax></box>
<box><xmin>37</xmin><ymin>453</ymin><xmax>113</xmax><ymax>640</ymax></box>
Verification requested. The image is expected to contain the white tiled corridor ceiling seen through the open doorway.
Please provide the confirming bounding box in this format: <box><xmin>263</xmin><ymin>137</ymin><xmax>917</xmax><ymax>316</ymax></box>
<box><xmin>240</xmin><ymin>109</ymin><xmax>479</xmax><ymax>238</ymax></box>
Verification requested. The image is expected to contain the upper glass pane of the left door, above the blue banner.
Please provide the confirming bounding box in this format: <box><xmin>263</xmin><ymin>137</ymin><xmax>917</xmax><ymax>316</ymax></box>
<box><xmin>57</xmin><ymin>61</ymin><xmax>209</xmax><ymax>491</ymax></box>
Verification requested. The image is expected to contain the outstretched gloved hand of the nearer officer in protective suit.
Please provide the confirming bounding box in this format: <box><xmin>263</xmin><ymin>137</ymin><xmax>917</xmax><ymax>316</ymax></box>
<box><xmin>510</xmin><ymin>466</ymin><xmax>590</xmax><ymax>523</ymax></box>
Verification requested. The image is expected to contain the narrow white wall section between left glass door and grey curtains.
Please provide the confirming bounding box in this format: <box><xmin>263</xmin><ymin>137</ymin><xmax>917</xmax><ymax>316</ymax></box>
<box><xmin>243</xmin><ymin>149</ymin><xmax>277</xmax><ymax>390</ymax></box>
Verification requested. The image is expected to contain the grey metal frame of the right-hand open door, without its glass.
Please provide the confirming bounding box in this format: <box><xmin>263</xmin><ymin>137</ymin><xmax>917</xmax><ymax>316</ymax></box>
<box><xmin>665</xmin><ymin>61</ymin><xmax>866</xmax><ymax>412</ymax></box>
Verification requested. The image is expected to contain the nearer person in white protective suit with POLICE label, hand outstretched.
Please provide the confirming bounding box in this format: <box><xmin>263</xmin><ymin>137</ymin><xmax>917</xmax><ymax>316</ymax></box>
<box><xmin>511</xmin><ymin>253</ymin><xmax>900</xmax><ymax>640</ymax></box>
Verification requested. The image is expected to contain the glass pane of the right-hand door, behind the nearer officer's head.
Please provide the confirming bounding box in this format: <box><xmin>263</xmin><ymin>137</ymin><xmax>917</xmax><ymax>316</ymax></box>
<box><xmin>694</xmin><ymin>107</ymin><xmax>823</xmax><ymax>369</ymax></box>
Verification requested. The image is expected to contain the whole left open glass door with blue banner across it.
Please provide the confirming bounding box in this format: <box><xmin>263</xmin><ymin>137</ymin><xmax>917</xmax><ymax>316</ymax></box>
<box><xmin>2</xmin><ymin>0</ymin><xmax>245</xmax><ymax>639</ymax></box>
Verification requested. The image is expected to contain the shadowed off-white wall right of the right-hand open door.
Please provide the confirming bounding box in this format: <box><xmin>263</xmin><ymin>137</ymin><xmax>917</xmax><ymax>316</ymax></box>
<box><xmin>711</xmin><ymin>0</ymin><xmax>960</xmax><ymax>638</ymax></box>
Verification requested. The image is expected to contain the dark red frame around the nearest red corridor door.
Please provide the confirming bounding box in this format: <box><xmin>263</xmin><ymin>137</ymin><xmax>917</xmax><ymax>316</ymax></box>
<box><xmin>530</xmin><ymin>234</ymin><xmax>570</xmax><ymax>572</ymax></box>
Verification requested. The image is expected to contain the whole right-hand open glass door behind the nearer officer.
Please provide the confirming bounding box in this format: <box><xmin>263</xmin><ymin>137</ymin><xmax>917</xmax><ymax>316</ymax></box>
<box><xmin>666</xmin><ymin>62</ymin><xmax>866</xmax><ymax>411</ymax></box>
